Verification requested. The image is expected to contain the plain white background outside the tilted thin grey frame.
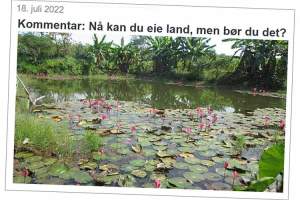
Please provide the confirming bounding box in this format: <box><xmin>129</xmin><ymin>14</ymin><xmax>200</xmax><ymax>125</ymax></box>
<box><xmin>0</xmin><ymin>0</ymin><xmax>300</xmax><ymax>200</ymax></box>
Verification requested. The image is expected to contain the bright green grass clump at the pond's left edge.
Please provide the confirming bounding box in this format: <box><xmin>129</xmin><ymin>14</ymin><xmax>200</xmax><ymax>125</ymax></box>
<box><xmin>15</xmin><ymin>113</ymin><xmax>102</xmax><ymax>158</ymax></box>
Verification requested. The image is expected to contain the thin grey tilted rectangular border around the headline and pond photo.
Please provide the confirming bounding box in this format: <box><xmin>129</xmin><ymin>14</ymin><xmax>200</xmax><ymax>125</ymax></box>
<box><xmin>5</xmin><ymin>0</ymin><xmax>296</xmax><ymax>200</ymax></box>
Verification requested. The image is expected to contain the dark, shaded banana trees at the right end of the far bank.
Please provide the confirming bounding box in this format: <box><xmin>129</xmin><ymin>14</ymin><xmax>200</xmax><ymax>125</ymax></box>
<box><xmin>224</xmin><ymin>39</ymin><xmax>288</xmax><ymax>89</ymax></box>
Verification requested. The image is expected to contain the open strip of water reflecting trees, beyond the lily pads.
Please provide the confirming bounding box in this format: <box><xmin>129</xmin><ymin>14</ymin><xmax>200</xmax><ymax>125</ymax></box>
<box><xmin>29</xmin><ymin>79</ymin><xmax>285</xmax><ymax>113</ymax></box>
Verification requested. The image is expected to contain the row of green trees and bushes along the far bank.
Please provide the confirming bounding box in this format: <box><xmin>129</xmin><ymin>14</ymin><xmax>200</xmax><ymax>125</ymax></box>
<box><xmin>18</xmin><ymin>33</ymin><xmax>288</xmax><ymax>89</ymax></box>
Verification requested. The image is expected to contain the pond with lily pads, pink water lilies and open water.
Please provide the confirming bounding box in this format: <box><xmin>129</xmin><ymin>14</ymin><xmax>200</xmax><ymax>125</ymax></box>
<box><xmin>14</xmin><ymin>76</ymin><xmax>285</xmax><ymax>190</ymax></box>
